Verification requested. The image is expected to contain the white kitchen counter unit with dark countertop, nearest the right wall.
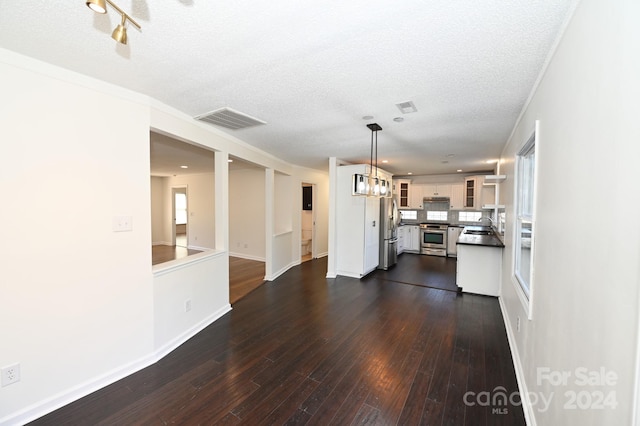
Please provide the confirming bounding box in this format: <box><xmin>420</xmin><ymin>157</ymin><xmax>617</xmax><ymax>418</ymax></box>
<box><xmin>456</xmin><ymin>226</ymin><xmax>504</xmax><ymax>297</ymax></box>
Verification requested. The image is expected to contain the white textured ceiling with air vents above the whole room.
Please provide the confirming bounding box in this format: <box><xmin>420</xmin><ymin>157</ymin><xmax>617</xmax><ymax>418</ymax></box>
<box><xmin>0</xmin><ymin>0</ymin><xmax>575</xmax><ymax>175</ymax></box>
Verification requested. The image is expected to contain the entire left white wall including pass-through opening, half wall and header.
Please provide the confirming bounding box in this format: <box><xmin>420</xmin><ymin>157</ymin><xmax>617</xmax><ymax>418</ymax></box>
<box><xmin>0</xmin><ymin>49</ymin><xmax>329</xmax><ymax>425</ymax></box>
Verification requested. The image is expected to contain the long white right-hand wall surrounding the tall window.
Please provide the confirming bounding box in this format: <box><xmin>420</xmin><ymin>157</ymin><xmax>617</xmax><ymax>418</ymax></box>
<box><xmin>500</xmin><ymin>0</ymin><xmax>640</xmax><ymax>425</ymax></box>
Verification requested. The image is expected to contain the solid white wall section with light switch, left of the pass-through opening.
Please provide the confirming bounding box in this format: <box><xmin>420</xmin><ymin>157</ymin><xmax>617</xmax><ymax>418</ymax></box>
<box><xmin>0</xmin><ymin>50</ymin><xmax>154</xmax><ymax>424</ymax></box>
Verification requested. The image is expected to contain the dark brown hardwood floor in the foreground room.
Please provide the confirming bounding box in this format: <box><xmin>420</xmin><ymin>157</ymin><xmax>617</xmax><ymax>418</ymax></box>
<box><xmin>27</xmin><ymin>255</ymin><xmax>525</xmax><ymax>426</ymax></box>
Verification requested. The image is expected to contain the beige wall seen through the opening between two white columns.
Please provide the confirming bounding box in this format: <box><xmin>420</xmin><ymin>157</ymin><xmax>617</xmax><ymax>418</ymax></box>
<box><xmin>229</xmin><ymin>168</ymin><xmax>266</xmax><ymax>261</ymax></box>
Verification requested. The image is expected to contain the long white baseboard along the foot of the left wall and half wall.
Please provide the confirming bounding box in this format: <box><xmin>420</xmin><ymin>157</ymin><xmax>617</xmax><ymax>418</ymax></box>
<box><xmin>0</xmin><ymin>304</ymin><xmax>232</xmax><ymax>426</ymax></box>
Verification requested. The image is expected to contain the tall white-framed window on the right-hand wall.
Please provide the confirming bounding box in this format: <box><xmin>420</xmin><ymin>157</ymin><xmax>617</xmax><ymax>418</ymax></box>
<box><xmin>514</xmin><ymin>123</ymin><xmax>537</xmax><ymax>300</ymax></box>
